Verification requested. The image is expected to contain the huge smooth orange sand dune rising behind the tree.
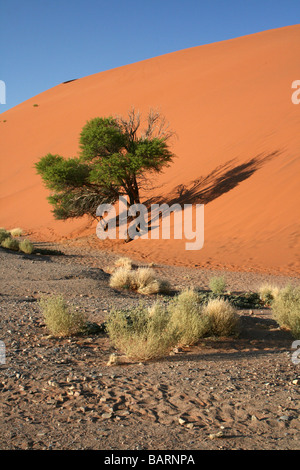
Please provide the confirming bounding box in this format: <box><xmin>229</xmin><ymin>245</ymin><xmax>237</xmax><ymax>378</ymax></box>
<box><xmin>0</xmin><ymin>25</ymin><xmax>300</xmax><ymax>275</ymax></box>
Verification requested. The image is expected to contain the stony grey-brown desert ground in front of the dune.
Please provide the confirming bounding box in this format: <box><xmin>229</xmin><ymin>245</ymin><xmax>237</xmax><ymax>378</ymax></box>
<box><xmin>0</xmin><ymin>239</ymin><xmax>300</xmax><ymax>451</ymax></box>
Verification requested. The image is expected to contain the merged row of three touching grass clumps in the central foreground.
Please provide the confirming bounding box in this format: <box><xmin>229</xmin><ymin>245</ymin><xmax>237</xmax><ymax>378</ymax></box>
<box><xmin>106</xmin><ymin>289</ymin><xmax>243</xmax><ymax>360</ymax></box>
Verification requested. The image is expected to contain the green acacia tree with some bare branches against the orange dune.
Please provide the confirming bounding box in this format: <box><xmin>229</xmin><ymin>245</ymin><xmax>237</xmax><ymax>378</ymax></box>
<box><xmin>35</xmin><ymin>109</ymin><xmax>174</xmax><ymax>219</ymax></box>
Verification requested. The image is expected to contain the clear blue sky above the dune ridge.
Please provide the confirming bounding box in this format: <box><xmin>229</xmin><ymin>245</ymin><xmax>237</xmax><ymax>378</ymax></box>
<box><xmin>0</xmin><ymin>0</ymin><xmax>300</xmax><ymax>113</ymax></box>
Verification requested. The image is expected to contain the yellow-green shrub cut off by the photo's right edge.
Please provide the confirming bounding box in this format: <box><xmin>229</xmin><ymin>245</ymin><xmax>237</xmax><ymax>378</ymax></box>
<box><xmin>271</xmin><ymin>286</ymin><xmax>300</xmax><ymax>339</ymax></box>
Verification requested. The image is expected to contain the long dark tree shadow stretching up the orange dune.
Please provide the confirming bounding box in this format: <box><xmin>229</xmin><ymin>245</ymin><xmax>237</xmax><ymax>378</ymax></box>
<box><xmin>144</xmin><ymin>151</ymin><xmax>280</xmax><ymax>207</ymax></box>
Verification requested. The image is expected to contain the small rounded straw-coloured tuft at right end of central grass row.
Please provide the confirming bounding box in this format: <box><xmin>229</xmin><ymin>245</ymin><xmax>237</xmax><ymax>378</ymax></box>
<box><xmin>202</xmin><ymin>299</ymin><xmax>239</xmax><ymax>336</ymax></box>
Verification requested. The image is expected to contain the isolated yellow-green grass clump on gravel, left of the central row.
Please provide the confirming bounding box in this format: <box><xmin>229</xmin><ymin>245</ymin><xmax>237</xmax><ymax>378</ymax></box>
<box><xmin>39</xmin><ymin>295</ymin><xmax>86</xmax><ymax>337</ymax></box>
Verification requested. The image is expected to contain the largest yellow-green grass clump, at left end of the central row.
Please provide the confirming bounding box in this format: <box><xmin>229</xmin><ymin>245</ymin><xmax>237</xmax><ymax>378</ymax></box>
<box><xmin>106</xmin><ymin>303</ymin><xmax>177</xmax><ymax>361</ymax></box>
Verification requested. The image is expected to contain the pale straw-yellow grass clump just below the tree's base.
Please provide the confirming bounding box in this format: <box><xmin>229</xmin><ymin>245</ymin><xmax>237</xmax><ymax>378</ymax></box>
<box><xmin>110</xmin><ymin>267</ymin><xmax>170</xmax><ymax>295</ymax></box>
